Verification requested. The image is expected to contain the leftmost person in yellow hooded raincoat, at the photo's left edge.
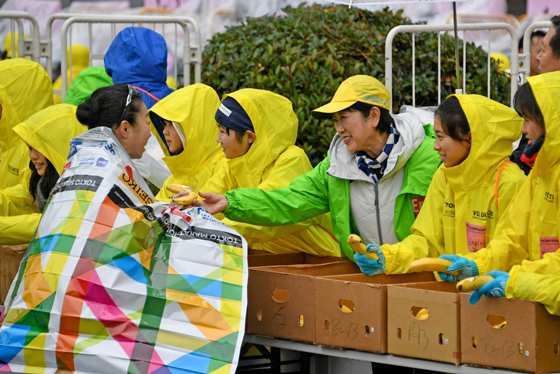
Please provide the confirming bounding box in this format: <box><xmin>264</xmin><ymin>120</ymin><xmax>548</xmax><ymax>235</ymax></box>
<box><xmin>0</xmin><ymin>58</ymin><xmax>53</xmax><ymax>189</ymax></box>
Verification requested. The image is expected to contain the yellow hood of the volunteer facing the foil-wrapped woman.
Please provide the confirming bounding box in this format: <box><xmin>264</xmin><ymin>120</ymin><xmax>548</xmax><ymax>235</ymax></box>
<box><xmin>150</xmin><ymin>83</ymin><xmax>222</xmax><ymax>174</ymax></box>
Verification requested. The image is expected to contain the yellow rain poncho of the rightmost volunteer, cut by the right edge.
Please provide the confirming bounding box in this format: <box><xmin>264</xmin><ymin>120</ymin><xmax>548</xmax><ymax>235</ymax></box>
<box><xmin>474</xmin><ymin>72</ymin><xmax>560</xmax><ymax>274</ymax></box>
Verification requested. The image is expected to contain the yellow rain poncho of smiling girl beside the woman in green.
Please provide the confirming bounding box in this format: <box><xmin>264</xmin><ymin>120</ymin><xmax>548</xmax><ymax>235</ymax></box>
<box><xmin>381</xmin><ymin>95</ymin><xmax>526</xmax><ymax>274</ymax></box>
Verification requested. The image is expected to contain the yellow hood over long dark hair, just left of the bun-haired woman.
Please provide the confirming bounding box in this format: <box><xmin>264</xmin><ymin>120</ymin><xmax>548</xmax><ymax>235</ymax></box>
<box><xmin>13</xmin><ymin>104</ymin><xmax>87</xmax><ymax>175</ymax></box>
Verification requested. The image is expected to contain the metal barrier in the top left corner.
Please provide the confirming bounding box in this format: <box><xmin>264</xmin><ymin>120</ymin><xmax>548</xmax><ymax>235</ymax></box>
<box><xmin>0</xmin><ymin>10</ymin><xmax>41</xmax><ymax>62</ymax></box>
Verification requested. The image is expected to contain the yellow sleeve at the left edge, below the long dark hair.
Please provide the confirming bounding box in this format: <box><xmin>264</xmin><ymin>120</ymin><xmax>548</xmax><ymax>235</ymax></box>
<box><xmin>0</xmin><ymin>213</ymin><xmax>41</xmax><ymax>245</ymax></box>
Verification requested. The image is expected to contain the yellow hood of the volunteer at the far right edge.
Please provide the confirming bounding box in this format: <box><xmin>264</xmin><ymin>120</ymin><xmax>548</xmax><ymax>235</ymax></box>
<box><xmin>527</xmin><ymin>71</ymin><xmax>560</xmax><ymax>178</ymax></box>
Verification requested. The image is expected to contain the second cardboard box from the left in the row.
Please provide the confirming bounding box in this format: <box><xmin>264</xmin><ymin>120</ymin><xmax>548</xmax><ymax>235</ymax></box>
<box><xmin>315</xmin><ymin>272</ymin><xmax>435</xmax><ymax>353</ymax></box>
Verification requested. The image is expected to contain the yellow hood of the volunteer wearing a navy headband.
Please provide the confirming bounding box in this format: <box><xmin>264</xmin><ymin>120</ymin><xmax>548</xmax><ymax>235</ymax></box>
<box><xmin>222</xmin><ymin>88</ymin><xmax>298</xmax><ymax>187</ymax></box>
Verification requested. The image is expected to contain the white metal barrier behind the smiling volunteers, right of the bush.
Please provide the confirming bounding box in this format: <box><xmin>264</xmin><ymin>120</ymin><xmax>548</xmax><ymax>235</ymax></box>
<box><xmin>385</xmin><ymin>23</ymin><xmax>518</xmax><ymax>112</ymax></box>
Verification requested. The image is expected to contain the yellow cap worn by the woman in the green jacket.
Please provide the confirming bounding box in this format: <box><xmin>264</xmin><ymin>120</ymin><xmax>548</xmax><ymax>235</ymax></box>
<box><xmin>311</xmin><ymin>75</ymin><xmax>391</xmax><ymax>119</ymax></box>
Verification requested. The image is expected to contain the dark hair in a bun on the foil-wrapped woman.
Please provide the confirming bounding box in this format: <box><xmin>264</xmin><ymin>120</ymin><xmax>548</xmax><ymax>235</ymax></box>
<box><xmin>76</xmin><ymin>84</ymin><xmax>142</xmax><ymax>130</ymax></box>
